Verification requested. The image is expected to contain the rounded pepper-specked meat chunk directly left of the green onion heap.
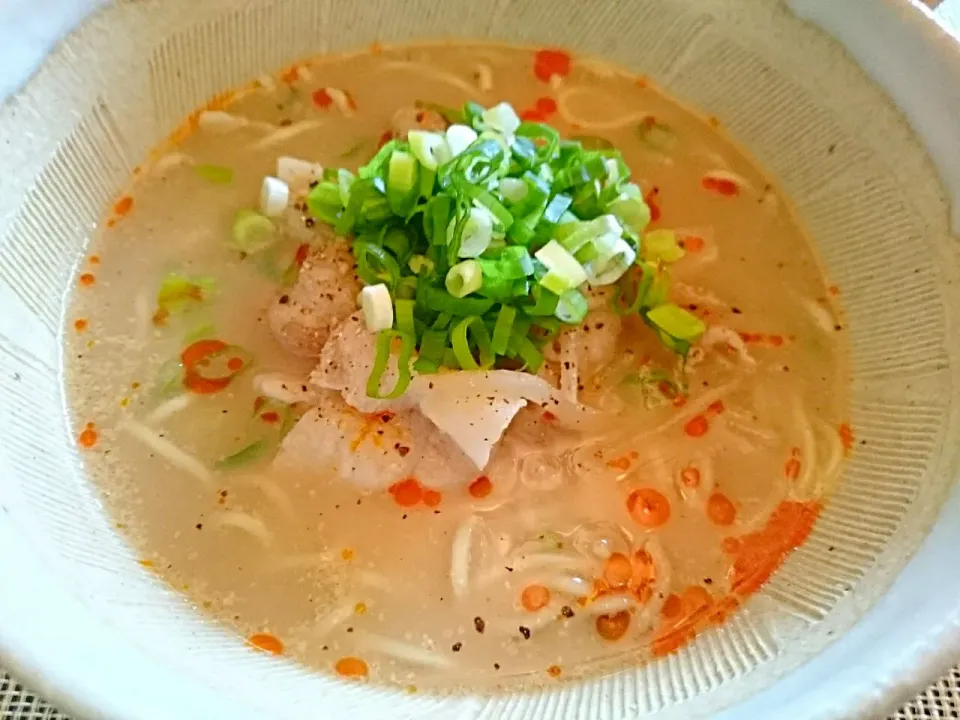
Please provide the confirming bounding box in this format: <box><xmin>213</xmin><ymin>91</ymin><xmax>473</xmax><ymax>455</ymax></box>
<box><xmin>267</xmin><ymin>232</ymin><xmax>363</xmax><ymax>357</ymax></box>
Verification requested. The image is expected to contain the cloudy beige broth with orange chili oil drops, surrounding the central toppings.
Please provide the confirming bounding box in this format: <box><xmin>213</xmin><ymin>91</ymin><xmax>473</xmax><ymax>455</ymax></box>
<box><xmin>65</xmin><ymin>40</ymin><xmax>851</xmax><ymax>690</ymax></box>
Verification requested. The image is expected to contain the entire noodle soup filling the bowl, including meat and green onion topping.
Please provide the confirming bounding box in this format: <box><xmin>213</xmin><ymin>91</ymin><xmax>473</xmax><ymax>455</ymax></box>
<box><xmin>65</xmin><ymin>45</ymin><xmax>852</xmax><ymax>690</ymax></box>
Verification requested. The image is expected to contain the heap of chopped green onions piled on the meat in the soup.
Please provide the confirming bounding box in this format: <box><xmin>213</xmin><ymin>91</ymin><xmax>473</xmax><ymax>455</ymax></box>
<box><xmin>300</xmin><ymin>102</ymin><xmax>703</xmax><ymax>398</ymax></box>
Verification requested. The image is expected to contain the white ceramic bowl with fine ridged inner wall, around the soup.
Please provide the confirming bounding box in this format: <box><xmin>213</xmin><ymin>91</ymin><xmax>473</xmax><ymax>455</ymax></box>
<box><xmin>0</xmin><ymin>0</ymin><xmax>960</xmax><ymax>720</ymax></box>
